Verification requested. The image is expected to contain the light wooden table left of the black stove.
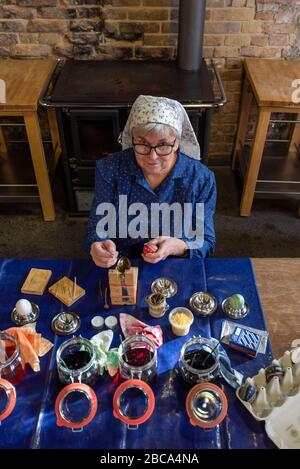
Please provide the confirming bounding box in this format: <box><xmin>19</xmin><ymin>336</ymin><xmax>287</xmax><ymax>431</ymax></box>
<box><xmin>0</xmin><ymin>59</ymin><xmax>60</xmax><ymax>221</ymax></box>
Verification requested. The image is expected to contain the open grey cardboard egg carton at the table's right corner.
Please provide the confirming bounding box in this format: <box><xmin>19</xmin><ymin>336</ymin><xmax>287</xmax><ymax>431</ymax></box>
<box><xmin>236</xmin><ymin>341</ymin><xmax>300</xmax><ymax>449</ymax></box>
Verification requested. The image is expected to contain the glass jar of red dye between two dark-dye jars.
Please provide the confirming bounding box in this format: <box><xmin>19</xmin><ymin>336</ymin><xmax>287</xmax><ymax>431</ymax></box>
<box><xmin>119</xmin><ymin>335</ymin><xmax>157</xmax><ymax>382</ymax></box>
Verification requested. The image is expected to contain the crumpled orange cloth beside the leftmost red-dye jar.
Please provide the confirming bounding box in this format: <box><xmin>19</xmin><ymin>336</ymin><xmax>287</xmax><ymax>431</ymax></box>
<box><xmin>3</xmin><ymin>322</ymin><xmax>53</xmax><ymax>371</ymax></box>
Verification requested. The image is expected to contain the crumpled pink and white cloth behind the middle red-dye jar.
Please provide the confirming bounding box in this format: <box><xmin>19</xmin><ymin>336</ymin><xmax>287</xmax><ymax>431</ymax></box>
<box><xmin>120</xmin><ymin>313</ymin><xmax>163</xmax><ymax>348</ymax></box>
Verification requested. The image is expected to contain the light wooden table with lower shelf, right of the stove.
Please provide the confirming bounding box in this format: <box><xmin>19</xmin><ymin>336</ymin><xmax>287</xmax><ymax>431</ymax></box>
<box><xmin>232</xmin><ymin>59</ymin><xmax>300</xmax><ymax>216</ymax></box>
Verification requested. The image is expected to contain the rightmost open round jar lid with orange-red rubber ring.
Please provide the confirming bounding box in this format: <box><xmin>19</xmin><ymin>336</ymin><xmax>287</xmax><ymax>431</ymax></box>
<box><xmin>186</xmin><ymin>383</ymin><xmax>228</xmax><ymax>428</ymax></box>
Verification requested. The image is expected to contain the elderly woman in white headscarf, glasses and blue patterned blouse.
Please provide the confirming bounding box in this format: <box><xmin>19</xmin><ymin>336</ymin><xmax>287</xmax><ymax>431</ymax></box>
<box><xmin>87</xmin><ymin>96</ymin><xmax>216</xmax><ymax>267</ymax></box>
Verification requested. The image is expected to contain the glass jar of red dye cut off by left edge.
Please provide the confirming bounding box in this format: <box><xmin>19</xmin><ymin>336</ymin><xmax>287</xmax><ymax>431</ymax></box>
<box><xmin>0</xmin><ymin>332</ymin><xmax>25</xmax><ymax>384</ymax></box>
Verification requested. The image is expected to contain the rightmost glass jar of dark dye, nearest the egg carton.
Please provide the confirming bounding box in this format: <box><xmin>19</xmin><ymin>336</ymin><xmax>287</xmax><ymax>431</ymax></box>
<box><xmin>178</xmin><ymin>336</ymin><xmax>220</xmax><ymax>384</ymax></box>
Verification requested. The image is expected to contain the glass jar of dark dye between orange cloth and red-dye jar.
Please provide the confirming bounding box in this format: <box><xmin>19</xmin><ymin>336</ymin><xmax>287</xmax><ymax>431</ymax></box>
<box><xmin>56</xmin><ymin>337</ymin><xmax>98</xmax><ymax>385</ymax></box>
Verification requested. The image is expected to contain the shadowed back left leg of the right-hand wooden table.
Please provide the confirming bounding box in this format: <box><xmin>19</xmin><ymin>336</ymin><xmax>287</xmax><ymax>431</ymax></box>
<box><xmin>231</xmin><ymin>77</ymin><xmax>253</xmax><ymax>169</ymax></box>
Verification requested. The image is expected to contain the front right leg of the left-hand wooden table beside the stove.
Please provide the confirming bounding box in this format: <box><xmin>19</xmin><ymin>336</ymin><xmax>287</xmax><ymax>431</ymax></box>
<box><xmin>24</xmin><ymin>112</ymin><xmax>55</xmax><ymax>221</ymax></box>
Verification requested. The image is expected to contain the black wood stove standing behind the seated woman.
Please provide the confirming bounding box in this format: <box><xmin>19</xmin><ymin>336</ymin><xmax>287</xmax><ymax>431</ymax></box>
<box><xmin>40</xmin><ymin>60</ymin><xmax>226</xmax><ymax>216</ymax></box>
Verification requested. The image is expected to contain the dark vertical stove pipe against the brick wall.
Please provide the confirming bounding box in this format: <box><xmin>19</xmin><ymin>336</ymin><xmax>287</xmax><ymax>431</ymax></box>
<box><xmin>177</xmin><ymin>0</ymin><xmax>206</xmax><ymax>71</ymax></box>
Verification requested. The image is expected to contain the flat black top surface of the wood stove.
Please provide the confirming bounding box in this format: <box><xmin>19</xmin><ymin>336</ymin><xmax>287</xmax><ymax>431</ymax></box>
<box><xmin>51</xmin><ymin>60</ymin><xmax>214</xmax><ymax>107</ymax></box>
